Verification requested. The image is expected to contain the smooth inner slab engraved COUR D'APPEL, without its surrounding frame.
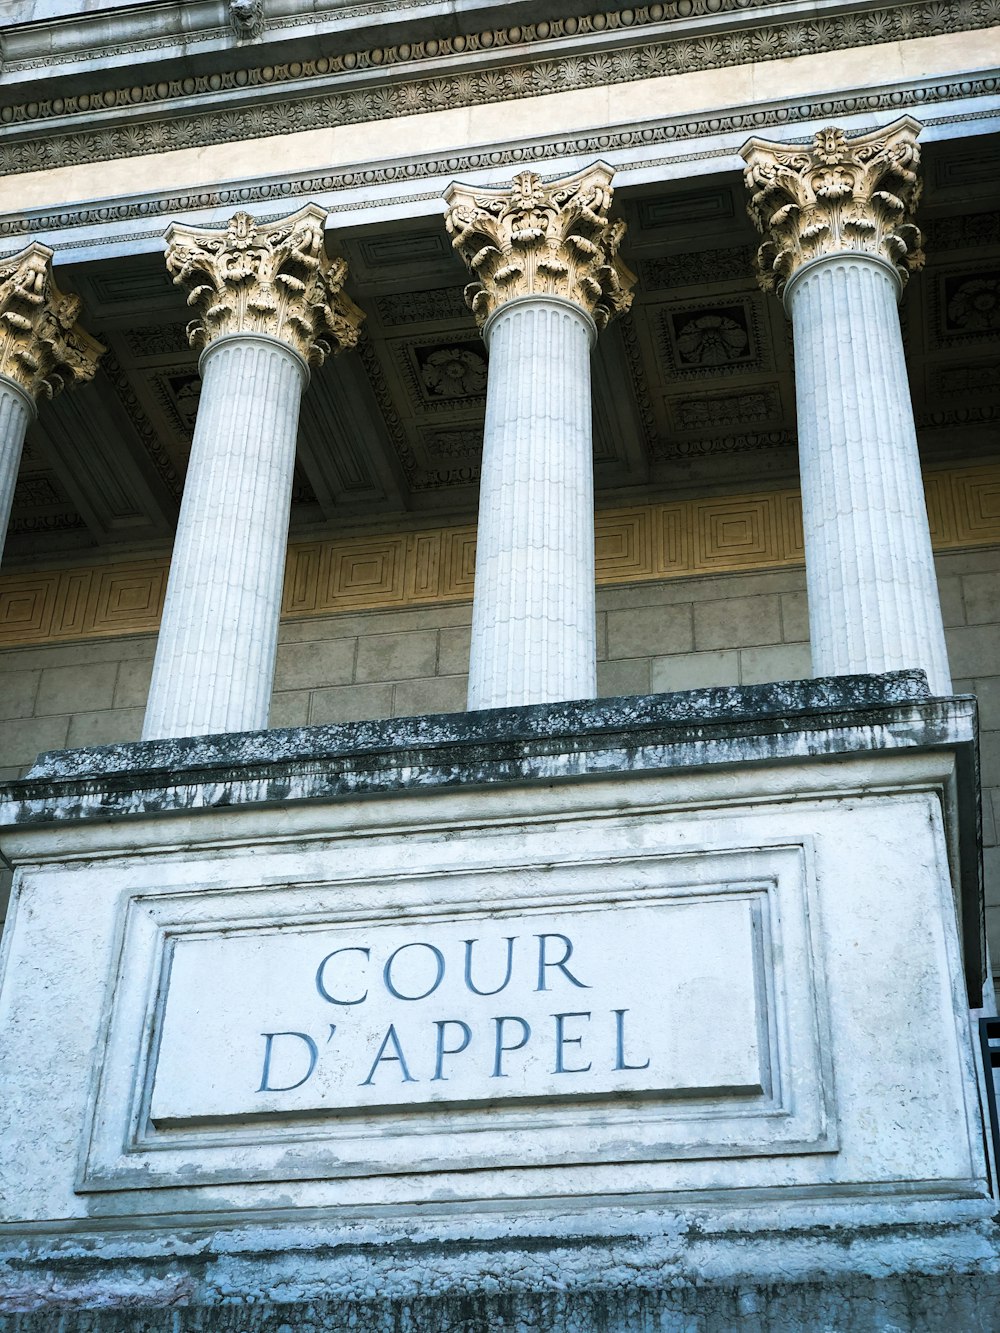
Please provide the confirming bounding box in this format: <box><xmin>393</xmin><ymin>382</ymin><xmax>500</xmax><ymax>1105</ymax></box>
<box><xmin>151</xmin><ymin>896</ymin><xmax>767</xmax><ymax>1125</ymax></box>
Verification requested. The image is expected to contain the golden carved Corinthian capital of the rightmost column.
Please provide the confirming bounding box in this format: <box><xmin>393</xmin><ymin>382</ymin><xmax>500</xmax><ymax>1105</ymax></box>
<box><xmin>743</xmin><ymin>116</ymin><xmax>924</xmax><ymax>296</ymax></box>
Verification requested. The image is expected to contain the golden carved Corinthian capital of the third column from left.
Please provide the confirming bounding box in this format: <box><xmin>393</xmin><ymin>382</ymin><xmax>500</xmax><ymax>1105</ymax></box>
<box><xmin>444</xmin><ymin>163</ymin><xmax>636</xmax><ymax>328</ymax></box>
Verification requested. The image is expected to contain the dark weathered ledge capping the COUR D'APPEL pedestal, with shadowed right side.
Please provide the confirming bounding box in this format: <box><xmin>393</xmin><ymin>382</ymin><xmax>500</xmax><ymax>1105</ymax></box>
<box><xmin>0</xmin><ymin>670</ymin><xmax>985</xmax><ymax>1006</ymax></box>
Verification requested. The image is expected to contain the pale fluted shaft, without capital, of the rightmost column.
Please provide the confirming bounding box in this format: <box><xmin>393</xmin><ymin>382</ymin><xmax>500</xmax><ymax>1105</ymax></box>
<box><xmin>785</xmin><ymin>253</ymin><xmax>951</xmax><ymax>694</ymax></box>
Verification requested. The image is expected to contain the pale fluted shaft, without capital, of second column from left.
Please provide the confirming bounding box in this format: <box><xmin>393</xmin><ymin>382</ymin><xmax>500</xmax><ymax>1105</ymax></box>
<box><xmin>143</xmin><ymin>335</ymin><xmax>307</xmax><ymax>738</ymax></box>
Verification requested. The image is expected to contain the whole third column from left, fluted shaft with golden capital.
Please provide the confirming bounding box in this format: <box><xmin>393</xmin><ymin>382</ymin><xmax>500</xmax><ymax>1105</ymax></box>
<box><xmin>445</xmin><ymin>163</ymin><xmax>635</xmax><ymax>709</ymax></box>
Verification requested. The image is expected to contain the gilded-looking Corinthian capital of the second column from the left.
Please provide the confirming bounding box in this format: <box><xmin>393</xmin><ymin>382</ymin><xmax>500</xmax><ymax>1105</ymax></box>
<box><xmin>167</xmin><ymin>204</ymin><xmax>364</xmax><ymax>365</ymax></box>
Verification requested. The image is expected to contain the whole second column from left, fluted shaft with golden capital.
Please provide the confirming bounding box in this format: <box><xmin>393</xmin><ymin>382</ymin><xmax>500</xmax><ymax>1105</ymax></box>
<box><xmin>143</xmin><ymin>204</ymin><xmax>363</xmax><ymax>738</ymax></box>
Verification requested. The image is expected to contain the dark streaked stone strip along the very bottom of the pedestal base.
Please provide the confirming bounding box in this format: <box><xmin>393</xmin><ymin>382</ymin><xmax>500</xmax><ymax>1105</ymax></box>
<box><xmin>0</xmin><ymin>1263</ymin><xmax>1000</xmax><ymax>1333</ymax></box>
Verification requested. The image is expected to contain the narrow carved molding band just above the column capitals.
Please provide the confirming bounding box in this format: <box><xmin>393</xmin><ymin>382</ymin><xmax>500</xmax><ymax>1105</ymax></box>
<box><xmin>0</xmin><ymin>76</ymin><xmax>1000</xmax><ymax>249</ymax></box>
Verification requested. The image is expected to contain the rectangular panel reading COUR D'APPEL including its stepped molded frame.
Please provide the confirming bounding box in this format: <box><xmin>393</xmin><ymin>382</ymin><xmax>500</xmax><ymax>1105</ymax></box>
<box><xmin>79</xmin><ymin>837</ymin><xmax>836</xmax><ymax>1190</ymax></box>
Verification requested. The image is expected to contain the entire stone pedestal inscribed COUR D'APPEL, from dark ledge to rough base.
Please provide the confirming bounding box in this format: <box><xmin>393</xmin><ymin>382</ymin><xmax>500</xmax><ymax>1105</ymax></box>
<box><xmin>0</xmin><ymin>673</ymin><xmax>1000</xmax><ymax>1333</ymax></box>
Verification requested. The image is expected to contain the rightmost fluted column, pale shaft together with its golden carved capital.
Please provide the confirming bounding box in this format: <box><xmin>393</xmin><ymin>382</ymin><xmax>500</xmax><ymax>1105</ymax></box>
<box><xmin>743</xmin><ymin>117</ymin><xmax>951</xmax><ymax>694</ymax></box>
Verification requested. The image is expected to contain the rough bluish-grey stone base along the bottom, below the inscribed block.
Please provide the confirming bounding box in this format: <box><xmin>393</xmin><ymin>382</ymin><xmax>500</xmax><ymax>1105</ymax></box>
<box><xmin>0</xmin><ymin>1209</ymin><xmax>1000</xmax><ymax>1333</ymax></box>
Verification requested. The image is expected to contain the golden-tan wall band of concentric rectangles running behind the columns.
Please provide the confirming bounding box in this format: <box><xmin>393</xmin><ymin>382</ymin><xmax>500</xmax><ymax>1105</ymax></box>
<box><xmin>0</xmin><ymin>463</ymin><xmax>1000</xmax><ymax>648</ymax></box>
